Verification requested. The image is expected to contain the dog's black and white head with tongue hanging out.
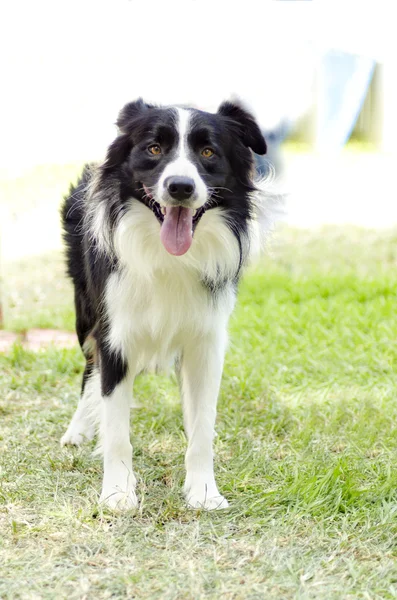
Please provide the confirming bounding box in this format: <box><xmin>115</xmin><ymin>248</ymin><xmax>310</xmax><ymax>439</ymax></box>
<box><xmin>104</xmin><ymin>100</ymin><xmax>266</xmax><ymax>255</ymax></box>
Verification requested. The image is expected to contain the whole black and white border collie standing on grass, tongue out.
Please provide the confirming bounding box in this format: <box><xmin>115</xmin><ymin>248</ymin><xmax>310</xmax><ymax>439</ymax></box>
<box><xmin>61</xmin><ymin>100</ymin><xmax>274</xmax><ymax>509</ymax></box>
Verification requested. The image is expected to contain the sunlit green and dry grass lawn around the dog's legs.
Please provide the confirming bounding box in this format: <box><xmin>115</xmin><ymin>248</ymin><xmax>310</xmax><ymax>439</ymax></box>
<box><xmin>0</xmin><ymin>229</ymin><xmax>397</xmax><ymax>600</ymax></box>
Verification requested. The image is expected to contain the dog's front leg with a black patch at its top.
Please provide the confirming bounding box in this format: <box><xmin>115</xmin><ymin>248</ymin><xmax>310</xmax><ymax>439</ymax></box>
<box><xmin>100</xmin><ymin>349</ymin><xmax>138</xmax><ymax>510</ymax></box>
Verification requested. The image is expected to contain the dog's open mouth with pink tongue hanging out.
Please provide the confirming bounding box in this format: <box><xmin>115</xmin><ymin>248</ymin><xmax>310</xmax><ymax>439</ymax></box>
<box><xmin>141</xmin><ymin>188</ymin><xmax>214</xmax><ymax>256</ymax></box>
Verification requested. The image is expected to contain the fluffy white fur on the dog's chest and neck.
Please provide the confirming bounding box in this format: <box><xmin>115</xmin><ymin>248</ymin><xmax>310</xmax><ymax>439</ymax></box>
<box><xmin>106</xmin><ymin>204</ymin><xmax>239</xmax><ymax>370</ymax></box>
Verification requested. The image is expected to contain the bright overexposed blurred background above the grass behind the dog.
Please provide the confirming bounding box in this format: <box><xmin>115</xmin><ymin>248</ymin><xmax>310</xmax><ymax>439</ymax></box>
<box><xmin>0</xmin><ymin>0</ymin><xmax>397</xmax><ymax>328</ymax></box>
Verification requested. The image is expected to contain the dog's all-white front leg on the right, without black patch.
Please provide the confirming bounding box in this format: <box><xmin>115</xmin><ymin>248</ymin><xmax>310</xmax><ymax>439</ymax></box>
<box><xmin>180</xmin><ymin>330</ymin><xmax>228</xmax><ymax>510</ymax></box>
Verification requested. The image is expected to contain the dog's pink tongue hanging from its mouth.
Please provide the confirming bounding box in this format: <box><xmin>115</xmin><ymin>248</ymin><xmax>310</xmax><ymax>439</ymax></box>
<box><xmin>160</xmin><ymin>206</ymin><xmax>193</xmax><ymax>256</ymax></box>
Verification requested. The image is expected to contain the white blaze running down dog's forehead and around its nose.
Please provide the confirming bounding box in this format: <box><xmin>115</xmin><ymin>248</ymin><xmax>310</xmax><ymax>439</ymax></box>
<box><xmin>156</xmin><ymin>108</ymin><xmax>208</xmax><ymax>208</ymax></box>
